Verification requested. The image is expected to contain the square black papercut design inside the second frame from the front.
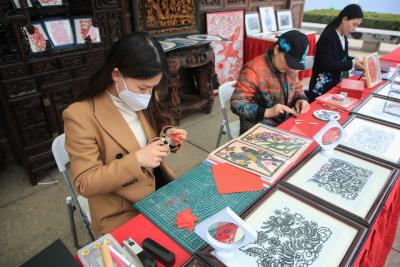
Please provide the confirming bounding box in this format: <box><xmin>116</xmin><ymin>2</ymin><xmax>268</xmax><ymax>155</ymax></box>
<box><xmin>308</xmin><ymin>158</ymin><xmax>373</xmax><ymax>200</ymax></box>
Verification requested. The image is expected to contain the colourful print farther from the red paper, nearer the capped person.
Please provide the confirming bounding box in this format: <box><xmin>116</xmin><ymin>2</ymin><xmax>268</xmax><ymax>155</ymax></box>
<box><xmin>241</xmin><ymin>125</ymin><xmax>309</xmax><ymax>157</ymax></box>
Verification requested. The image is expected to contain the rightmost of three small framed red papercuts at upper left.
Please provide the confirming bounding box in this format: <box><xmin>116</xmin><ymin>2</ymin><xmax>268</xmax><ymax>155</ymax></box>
<box><xmin>72</xmin><ymin>17</ymin><xmax>101</xmax><ymax>44</ymax></box>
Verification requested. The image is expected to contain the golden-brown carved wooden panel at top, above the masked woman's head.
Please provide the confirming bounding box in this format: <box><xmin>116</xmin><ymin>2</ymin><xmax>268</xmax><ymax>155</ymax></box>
<box><xmin>132</xmin><ymin>0</ymin><xmax>199</xmax><ymax>35</ymax></box>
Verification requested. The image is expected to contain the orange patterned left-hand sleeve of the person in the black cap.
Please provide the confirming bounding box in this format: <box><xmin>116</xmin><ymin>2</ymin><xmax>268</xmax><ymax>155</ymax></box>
<box><xmin>230</xmin><ymin>67</ymin><xmax>265</xmax><ymax>122</ymax></box>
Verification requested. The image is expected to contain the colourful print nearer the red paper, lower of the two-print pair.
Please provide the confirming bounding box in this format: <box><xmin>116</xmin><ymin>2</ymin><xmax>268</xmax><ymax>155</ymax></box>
<box><xmin>211</xmin><ymin>141</ymin><xmax>287</xmax><ymax>177</ymax></box>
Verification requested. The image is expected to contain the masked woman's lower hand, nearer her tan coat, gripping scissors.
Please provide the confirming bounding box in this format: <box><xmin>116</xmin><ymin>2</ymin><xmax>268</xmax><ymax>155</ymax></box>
<box><xmin>136</xmin><ymin>140</ymin><xmax>169</xmax><ymax>168</ymax></box>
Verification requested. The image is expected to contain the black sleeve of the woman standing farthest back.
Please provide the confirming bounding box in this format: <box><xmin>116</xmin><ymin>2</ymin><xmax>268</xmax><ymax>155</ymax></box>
<box><xmin>316</xmin><ymin>37</ymin><xmax>353</xmax><ymax>72</ymax></box>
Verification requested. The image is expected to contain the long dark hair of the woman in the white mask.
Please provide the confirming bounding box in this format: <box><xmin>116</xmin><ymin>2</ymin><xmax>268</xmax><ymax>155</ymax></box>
<box><xmin>76</xmin><ymin>33</ymin><xmax>172</xmax><ymax>132</ymax></box>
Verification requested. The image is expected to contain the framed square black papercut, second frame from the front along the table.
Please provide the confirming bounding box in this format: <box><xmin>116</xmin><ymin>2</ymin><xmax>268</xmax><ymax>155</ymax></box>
<box><xmin>282</xmin><ymin>148</ymin><xmax>397</xmax><ymax>226</ymax></box>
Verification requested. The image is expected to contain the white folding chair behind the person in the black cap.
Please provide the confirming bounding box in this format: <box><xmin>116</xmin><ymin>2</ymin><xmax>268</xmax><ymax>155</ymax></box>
<box><xmin>215</xmin><ymin>81</ymin><xmax>240</xmax><ymax>147</ymax></box>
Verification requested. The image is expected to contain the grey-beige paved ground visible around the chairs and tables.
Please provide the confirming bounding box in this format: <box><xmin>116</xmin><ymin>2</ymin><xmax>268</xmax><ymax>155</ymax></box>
<box><xmin>0</xmin><ymin>37</ymin><xmax>400</xmax><ymax>267</ymax></box>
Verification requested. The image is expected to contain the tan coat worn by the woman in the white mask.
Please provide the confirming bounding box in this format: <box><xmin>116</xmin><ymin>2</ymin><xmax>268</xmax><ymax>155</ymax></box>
<box><xmin>63</xmin><ymin>93</ymin><xmax>174</xmax><ymax>233</ymax></box>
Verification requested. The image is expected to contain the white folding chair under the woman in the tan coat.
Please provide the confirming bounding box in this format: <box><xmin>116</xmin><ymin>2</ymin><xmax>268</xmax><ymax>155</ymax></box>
<box><xmin>51</xmin><ymin>134</ymin><xmax>95</xmax><ymax>248</ymax></box>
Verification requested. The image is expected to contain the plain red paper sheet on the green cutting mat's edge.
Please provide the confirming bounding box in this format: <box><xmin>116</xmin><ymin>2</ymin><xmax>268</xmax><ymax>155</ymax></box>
<box><xmin>211</xmin><ymin>163</ymin><xmax>264</xmax><ymax>194</ymax></box>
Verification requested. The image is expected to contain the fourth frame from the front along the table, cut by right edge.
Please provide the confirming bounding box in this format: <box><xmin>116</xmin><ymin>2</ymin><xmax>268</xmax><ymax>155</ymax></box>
<box><xmin>352</xmin><ymin>95</ymin><xmax>400</xmax><ymax>126</ymax></box>
